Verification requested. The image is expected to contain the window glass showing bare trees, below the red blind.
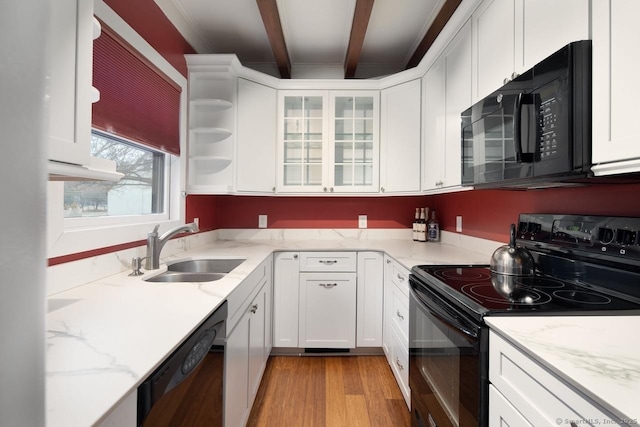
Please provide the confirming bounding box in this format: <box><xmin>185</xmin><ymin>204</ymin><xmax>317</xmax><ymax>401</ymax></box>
<box><xmin>64</xmin><ymin>130</ymin><xmax>165</xmax><ymax>218</ymax></box>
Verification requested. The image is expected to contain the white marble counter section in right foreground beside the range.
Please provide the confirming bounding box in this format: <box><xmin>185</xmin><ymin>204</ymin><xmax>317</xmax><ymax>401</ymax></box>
<box><xmin>485</xmin><ymin>316</ymin><xmax>640</xmax><ymax>424</ymax></box>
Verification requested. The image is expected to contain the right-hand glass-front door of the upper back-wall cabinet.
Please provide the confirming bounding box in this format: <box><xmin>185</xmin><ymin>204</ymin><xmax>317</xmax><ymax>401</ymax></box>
<box><xmin>329</xmin><ymin>92</ymin><xmax>379</xmax><ymax>192</ymax></box>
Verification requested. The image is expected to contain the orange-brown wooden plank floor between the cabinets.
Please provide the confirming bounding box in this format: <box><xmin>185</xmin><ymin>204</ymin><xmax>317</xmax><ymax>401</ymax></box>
<box><xmin>247</xmin><ymin>356</ymin><xmax>410</xmax><ymax>427</ymax></box>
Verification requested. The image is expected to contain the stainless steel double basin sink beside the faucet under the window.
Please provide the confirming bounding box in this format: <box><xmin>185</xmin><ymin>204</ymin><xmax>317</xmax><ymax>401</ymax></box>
<box><xmin>145</xmin><ymin>259</ymin><xmax>246</xmax><ymax>282</ymax></box>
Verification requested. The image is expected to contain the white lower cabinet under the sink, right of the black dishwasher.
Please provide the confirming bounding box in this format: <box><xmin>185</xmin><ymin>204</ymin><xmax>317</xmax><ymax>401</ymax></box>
<box><xmin>224</xmin><ymin>258</ymin><xmax>272</xmax><ymax>427</ymax></box>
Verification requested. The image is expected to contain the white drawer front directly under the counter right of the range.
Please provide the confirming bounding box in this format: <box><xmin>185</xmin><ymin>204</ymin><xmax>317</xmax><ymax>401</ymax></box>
<box><xmin>489</xmin><ymin>331</ymin><xmax>615</xmax><ymax>425</ymax></box>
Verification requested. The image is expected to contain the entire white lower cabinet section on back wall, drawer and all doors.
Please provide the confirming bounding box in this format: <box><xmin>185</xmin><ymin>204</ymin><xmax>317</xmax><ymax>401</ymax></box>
<box><xmin>273</xmin><ymin>251</ymin><xmax>384</xmax><ymax>349</ymax></box>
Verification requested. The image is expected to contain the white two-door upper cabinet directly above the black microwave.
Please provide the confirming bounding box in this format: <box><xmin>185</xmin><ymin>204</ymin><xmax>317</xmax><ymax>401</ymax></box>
<box><xmin>472</xmin><ymin>0</ymin><xmax>589</xmax><ymax>102</ymax></box>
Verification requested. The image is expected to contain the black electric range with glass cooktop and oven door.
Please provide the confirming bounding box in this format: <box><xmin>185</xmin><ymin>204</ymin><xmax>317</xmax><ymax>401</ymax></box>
<box><xmin>409</xmin><ymin>214</ymin><xmax>640</xmax><ymax>427</ymax></box>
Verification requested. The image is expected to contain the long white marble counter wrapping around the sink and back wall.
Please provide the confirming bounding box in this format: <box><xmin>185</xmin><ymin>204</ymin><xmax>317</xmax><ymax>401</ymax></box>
<box><xmin>46</xmin><ymin>232</ymin><xmax>496</xmax><ymax>427</ymax></box>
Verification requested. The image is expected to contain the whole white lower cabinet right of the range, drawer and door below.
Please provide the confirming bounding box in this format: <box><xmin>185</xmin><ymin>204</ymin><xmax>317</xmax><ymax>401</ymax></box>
<box><xmin>489</xmin><ymin>331</ymin><xmax>624</xmax><ymax>426</ymax></box>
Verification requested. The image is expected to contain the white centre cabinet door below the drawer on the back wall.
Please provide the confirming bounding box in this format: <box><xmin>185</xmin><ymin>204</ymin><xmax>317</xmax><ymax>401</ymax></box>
<box><xmin>298</xmin><ymin>273</ymin><xmax>357</xmax><ymax>348</ymax></box>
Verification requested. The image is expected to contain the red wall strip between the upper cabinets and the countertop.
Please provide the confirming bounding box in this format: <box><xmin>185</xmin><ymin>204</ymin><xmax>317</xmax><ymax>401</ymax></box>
<box><xmin>187</xmin><ymin>184</ymin><xmax>640</xmax><ymax>242</ymax></box>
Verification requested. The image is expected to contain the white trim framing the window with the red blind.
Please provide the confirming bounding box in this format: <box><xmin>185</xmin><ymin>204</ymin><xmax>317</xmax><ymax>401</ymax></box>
<box><xmin>47</xmin><ymin>0</ymin><xmax>187</xmax><ymax>258</ymax></box>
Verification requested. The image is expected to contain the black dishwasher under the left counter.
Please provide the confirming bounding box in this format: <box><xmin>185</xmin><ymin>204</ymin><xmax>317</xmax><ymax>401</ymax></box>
<box><xmin>138</xmin><ymin>302</ymin><xmax>227</xmax><ymax>427</ymax></box>
